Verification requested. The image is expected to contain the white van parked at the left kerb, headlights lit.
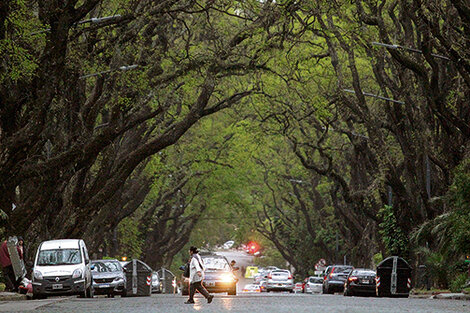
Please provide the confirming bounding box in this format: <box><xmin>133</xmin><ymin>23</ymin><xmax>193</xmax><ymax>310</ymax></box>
<box><xmin>33</xmin><ymin>239</ymin><xmax>93</xmax><ymax>298</ymax></box>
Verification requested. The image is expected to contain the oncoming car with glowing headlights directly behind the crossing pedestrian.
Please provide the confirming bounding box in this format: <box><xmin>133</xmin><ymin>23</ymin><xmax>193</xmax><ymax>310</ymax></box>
<box><xmin>182</xmin><ymin>254</ymin><xmax>238</xmax><ymax>295</ymax></box>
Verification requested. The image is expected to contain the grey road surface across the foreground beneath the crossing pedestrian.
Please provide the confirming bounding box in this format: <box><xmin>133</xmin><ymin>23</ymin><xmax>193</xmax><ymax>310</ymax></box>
<box><xmin>0</xmin><ymin>293</ymin><xmax>470</xmax><ymax>313</ymax></box>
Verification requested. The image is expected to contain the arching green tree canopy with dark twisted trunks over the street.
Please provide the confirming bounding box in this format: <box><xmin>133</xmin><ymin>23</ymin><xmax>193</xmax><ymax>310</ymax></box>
<box><xmin>0</xmin><ymin>0</ymin><xmax>470</xmax><ymax>288</ymax></box>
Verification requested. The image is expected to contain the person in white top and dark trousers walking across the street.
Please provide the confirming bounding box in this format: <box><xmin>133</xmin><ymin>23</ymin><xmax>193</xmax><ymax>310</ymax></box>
<box><xmin>185</xmin><ymin>247</ymin><xmax>214</xmax><ymax>304</ymax></box>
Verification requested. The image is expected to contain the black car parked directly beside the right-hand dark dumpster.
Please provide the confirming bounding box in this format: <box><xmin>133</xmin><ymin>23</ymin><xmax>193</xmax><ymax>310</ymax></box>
<box><xmin>344</xmin><ymin>268</ymin><xmax>376</xmax><ymax>296</ymax></box>
